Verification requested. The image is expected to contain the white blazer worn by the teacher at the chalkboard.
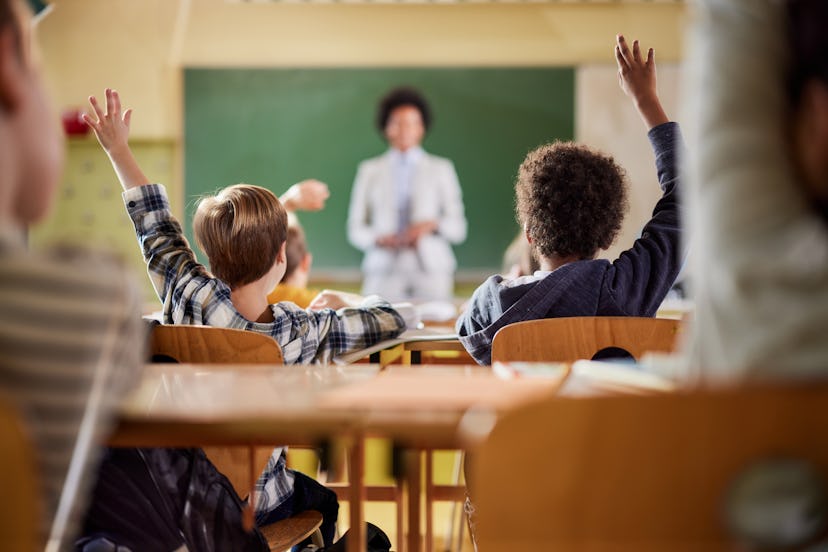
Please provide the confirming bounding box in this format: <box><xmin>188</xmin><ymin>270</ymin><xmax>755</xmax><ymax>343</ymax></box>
<box><xmin>348</xmin><ymin>151</ymin><xmax>466</xmax><ymax>273</ymax></box>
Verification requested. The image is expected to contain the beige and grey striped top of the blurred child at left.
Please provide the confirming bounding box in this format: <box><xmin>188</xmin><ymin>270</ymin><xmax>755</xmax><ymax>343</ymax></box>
<box><xmin>0</xmin><ymin>245</ymin><xmax>144</xmax><ymax>542</ymax></box>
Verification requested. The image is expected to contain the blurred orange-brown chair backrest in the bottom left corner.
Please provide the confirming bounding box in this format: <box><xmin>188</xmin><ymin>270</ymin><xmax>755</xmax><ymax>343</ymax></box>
<box><xmin>0</xmin><ymin>400</ymin><xmax>44</xmax><ymax>551</ymax></box>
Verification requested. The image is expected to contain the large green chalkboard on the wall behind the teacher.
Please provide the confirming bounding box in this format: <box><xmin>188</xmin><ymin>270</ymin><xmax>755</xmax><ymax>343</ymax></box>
<box><xmin>184</xmin><ymin>67</ymin><xmax>574</xmax><ymax>270</ymax></box>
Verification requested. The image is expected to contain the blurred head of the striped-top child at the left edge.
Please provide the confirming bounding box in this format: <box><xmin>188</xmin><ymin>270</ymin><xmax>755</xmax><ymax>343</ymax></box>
<box><xmin>0</xmin><ymin>0</ymin><xmax>63</xmax><ymax>226</ymax></box>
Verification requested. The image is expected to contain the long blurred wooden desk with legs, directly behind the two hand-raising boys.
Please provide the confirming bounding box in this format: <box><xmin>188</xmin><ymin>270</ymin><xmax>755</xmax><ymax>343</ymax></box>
<box><xmin>111</xmin><ymin>364</ymin><xmax>560</xmax><ymax>552</ymax></box>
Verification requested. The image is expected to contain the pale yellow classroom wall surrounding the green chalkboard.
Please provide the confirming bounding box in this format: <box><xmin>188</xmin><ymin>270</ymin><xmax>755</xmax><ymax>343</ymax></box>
<box><xmin>37</xmin><ymin>0</ymin><xmax>687</xmax><ymax>294</ymax></box>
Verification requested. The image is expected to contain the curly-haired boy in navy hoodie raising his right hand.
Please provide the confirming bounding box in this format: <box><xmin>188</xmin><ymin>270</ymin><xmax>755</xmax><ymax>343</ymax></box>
<box><xmin>457</xmin><ymin>35</ymin><xmax>682</xmax><ymax>364</ymax></box>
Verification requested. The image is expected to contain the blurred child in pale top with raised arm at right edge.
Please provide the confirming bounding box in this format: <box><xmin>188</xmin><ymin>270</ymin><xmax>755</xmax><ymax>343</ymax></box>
<box><xmin>684</xmin><ymin>0</ymin><xmax>828</xmax><ymax>382</ymax></box>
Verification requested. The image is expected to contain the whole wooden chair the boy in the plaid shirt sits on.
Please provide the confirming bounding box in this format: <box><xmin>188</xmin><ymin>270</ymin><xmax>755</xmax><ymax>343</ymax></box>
<box><xmin>150</xmin><ymin>324</ymin><xmax>323</xmax><ymax>552</ymax></box>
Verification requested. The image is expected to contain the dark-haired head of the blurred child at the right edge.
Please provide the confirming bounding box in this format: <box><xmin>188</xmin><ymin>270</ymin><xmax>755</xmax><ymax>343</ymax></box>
<box><xmin>787</xmin><ymin>0</ymin><xmax>828</xmax><ymax>212</ymax></box>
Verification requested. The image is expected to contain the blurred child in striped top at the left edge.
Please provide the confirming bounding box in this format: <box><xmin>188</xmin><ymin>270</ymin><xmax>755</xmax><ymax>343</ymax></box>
<box><xmin>0</xmin><ymin>0</ymin><xmax>144</xmax><ymax>548</ymax></box>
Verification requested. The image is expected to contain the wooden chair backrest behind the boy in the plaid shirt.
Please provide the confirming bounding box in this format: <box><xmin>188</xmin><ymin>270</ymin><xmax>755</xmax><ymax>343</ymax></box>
<box><xmin>150</xmin><ymin>324</ymin><xmax>284</xmax><ymax>364</ymax></box>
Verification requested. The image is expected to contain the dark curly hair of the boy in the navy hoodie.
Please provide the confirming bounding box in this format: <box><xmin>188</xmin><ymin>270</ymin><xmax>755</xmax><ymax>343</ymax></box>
<box><xmin>515</xmin><ymin>142</ymin><xmax>628</xmax><ymax>259</ymax></box>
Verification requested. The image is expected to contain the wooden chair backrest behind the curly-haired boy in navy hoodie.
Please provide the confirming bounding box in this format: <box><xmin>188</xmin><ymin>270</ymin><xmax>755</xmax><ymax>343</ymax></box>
<box><xmin>492</xmin><ymin>316</ymin><xmax>682</xmax><ymax>362</ymax></box>
